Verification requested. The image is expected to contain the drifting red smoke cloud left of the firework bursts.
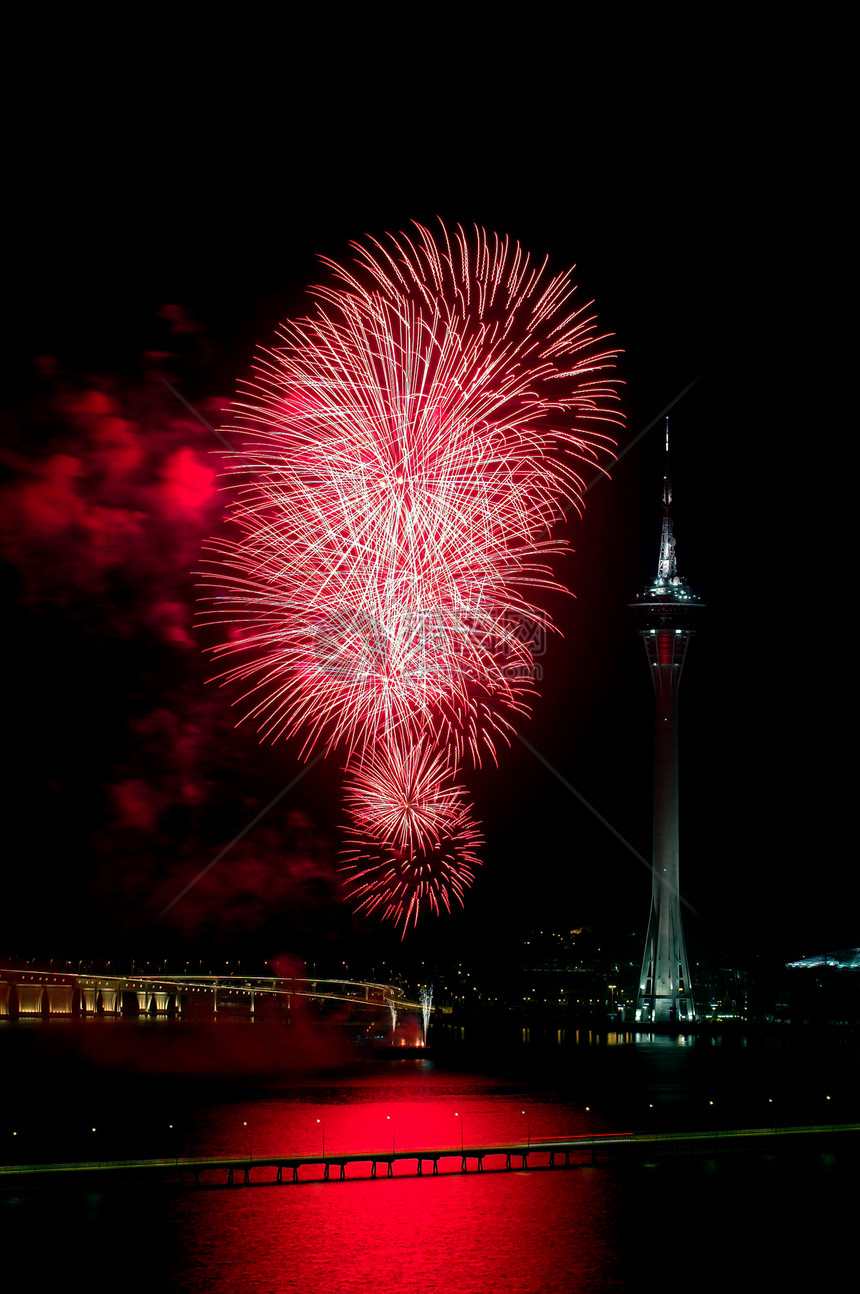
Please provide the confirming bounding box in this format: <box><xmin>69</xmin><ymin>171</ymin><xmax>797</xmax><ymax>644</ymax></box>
<box><xmin>0</xmin><ymin>344</ymin><xmax>340</xmax><ymax>955</ymax></box>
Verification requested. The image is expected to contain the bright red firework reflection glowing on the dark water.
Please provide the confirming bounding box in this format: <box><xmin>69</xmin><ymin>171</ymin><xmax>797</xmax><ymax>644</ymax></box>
<box><xmin>171</xmin><ymin>1076</ymin><xmax>622</xmax><ymax>1294</ymax></box>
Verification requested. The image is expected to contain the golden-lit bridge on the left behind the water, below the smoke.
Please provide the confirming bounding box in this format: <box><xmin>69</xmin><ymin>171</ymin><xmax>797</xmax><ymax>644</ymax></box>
<box><xmin>0</xmin><ymin>968</ymin><xmax>423</xmax><ymax>1029</ymax></box>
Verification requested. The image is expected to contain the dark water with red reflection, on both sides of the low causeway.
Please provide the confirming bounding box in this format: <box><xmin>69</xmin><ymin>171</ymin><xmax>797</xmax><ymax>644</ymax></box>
<box><xmin>0</xmin><ymin>1021</ymin><xmax>857</xmax><ymax>1294</ymax></box>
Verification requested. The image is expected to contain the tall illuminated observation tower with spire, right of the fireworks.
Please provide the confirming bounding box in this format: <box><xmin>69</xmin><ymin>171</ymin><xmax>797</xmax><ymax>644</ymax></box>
<box><xmin>631</xmin><ymin>418</ymin><xmax>704</xmax><ymax>1024</ymax></box>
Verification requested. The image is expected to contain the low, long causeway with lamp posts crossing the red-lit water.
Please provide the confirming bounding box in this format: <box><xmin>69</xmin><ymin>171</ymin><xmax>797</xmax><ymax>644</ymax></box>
<box><xmin>0</xmin><ymin>1123</ymin><xmax>860</xmax><ymax>1188</ymax></box>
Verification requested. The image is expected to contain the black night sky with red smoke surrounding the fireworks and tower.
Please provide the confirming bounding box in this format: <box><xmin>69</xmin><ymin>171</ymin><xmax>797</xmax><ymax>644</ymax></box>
<box><xmin>0</xmin><ymin>50</ymin><xmax>859</xmax><ymax>965</ymax></box>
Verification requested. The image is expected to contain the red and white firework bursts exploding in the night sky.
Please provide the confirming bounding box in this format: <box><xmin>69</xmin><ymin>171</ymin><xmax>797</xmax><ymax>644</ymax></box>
<box><xmin>204</xmin><ymin>225</ymin><xmax>621</xmax><ymax>930</ymax></box>
